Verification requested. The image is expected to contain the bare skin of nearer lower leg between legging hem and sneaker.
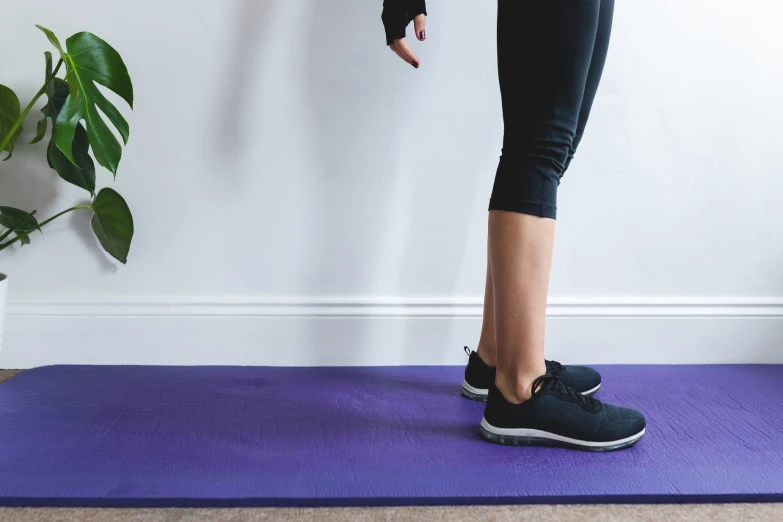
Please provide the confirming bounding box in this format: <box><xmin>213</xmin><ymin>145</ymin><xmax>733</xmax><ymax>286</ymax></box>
<box><xmin>494</xmin><ymin>210</ymin><xmax>555</xmax><ymax>403</ymax></box>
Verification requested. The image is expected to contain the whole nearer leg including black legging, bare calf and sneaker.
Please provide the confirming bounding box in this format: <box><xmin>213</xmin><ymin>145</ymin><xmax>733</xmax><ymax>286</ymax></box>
<box><xmin>480</xmin><ymin>0</ymin><xmax>646</xmax><ymax>451</ymax></box>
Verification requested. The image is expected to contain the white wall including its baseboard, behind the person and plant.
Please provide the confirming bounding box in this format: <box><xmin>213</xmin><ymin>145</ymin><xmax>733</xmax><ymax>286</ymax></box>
<box><xmin>0</xmin><ymin>0</ymin><xmax>783</xmax><ymax>367</ymax></box>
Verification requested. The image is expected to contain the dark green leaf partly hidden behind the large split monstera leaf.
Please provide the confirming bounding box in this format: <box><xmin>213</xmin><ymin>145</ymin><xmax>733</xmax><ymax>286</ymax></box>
<box><xmin>41</xmin><ymin>78</ymin><xmax>95</xmax><ymax>196</ymax></box>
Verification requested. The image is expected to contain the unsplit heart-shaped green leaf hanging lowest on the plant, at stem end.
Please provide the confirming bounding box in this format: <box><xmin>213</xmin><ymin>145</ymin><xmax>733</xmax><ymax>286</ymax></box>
<box><xmin>92</xmin><ymin>188</ymin><xmax>133</xmax><ymax>264</ymax></box>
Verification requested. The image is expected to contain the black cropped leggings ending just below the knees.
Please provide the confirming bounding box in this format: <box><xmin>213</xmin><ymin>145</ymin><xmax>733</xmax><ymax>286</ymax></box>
<box><xmin>489</xmin><ymin>0</ymin><xmax>614</xmax><ymax>219</ymax></box>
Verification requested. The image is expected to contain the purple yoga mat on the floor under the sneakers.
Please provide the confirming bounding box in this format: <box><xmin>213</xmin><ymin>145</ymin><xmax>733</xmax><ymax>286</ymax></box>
<box><xmin>0</xmin><ymin>366</ymin><xmax>783</xmax><ymax>506</ymax></box>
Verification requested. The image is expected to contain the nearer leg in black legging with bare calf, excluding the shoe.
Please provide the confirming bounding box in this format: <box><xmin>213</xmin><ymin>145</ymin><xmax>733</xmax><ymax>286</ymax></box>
<box><xmin>489</xmin><ymin>0</ymin><xmax>601</xmax><ymax>403</ymax></box>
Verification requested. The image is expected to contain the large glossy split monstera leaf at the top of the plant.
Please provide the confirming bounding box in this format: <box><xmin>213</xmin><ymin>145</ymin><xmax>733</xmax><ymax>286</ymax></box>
<box><xmin>47</xmin><ymin>33</ymin><xmax>133</xmax><ymax>176</ymax></box>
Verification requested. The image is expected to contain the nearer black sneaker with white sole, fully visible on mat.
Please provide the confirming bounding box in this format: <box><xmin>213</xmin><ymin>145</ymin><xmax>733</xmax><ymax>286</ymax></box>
<box><xmin>481</xmin><ymin>372</ymin><xmax>646</xmax><ymax>451</ymax></box>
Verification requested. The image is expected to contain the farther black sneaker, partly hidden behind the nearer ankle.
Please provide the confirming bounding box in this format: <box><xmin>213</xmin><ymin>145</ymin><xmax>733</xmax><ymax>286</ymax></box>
<box><xmin>462</xmin><ymin>346</ymin><xmax>601</xmax><ymax>401</ymax></box>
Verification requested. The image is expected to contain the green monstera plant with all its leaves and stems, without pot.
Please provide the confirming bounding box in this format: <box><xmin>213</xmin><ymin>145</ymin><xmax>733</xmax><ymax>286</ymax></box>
<box><xmin>0</xmin><ymin>26</ymin><xmax>133</xmax><ymax>263</ymax></box>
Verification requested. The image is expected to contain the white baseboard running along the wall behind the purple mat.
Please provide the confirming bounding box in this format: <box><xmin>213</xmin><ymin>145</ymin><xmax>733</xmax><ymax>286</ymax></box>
<box><xmin>0</xmin><ymin>297</ymin><xmax>783</xmax><ymax>368</ymax></box>
